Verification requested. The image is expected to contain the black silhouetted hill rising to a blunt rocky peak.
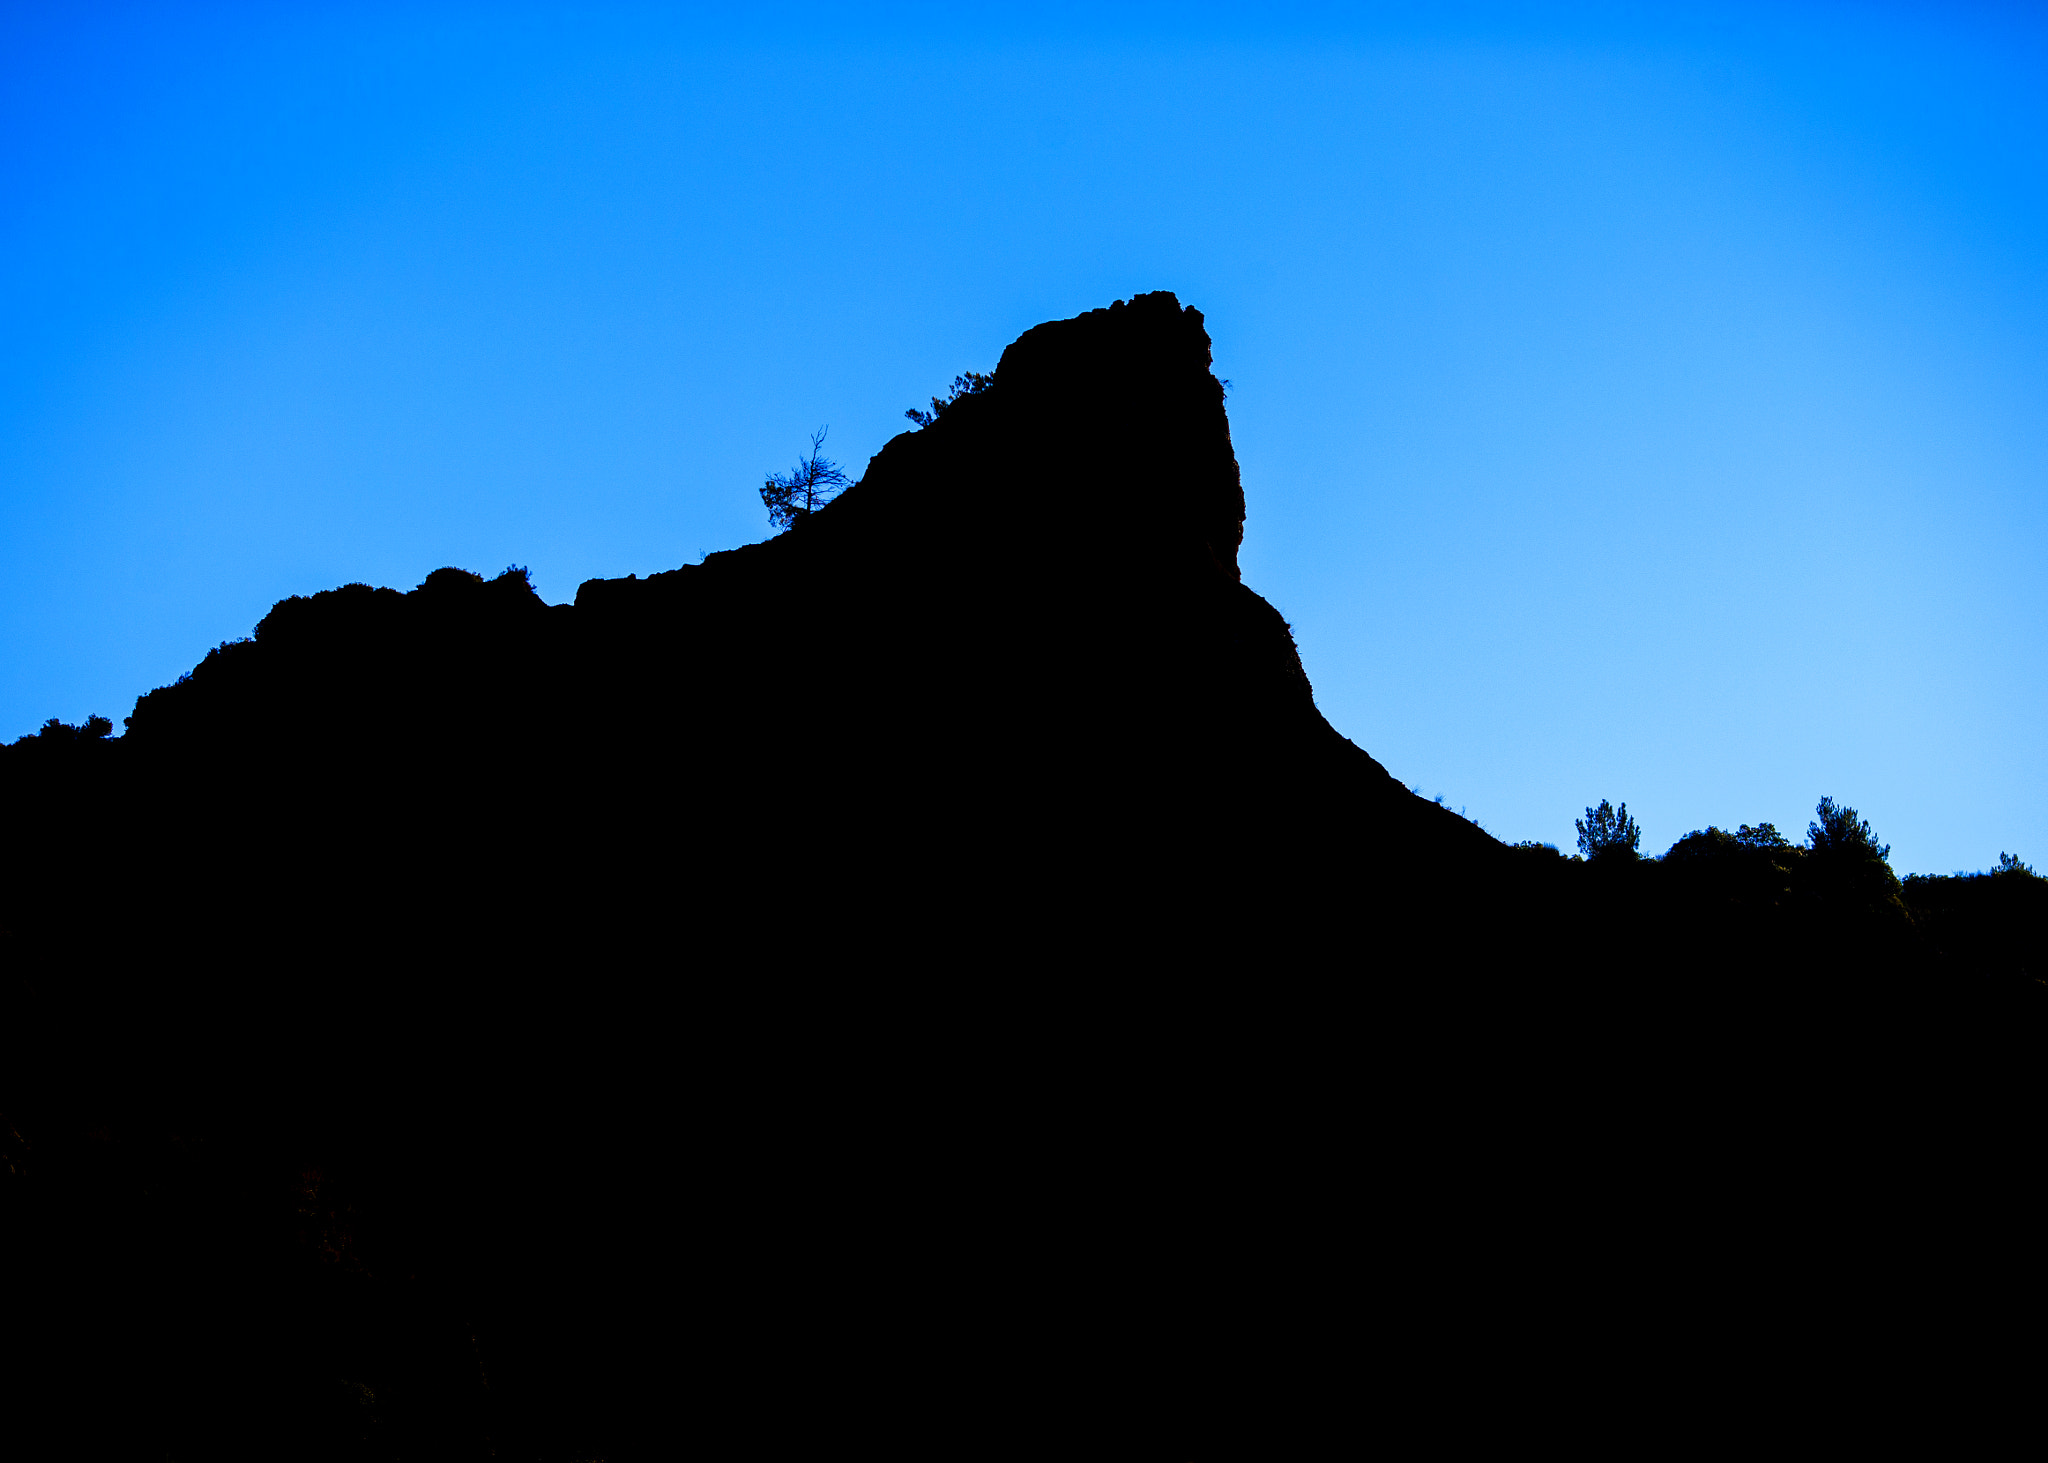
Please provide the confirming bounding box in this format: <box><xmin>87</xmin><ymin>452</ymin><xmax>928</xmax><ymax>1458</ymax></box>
<box><xmin>0</xmin><ymin>295</ymin><xmax>2040</xmax><ymax>1459</ymax></box>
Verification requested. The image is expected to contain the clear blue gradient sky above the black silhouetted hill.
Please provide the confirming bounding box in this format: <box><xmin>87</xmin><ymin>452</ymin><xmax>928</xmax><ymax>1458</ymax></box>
<box><xmin>0</xmin><ymin>4</ymin><xmax>2048</xmax><ymax>871</ymax></box>
